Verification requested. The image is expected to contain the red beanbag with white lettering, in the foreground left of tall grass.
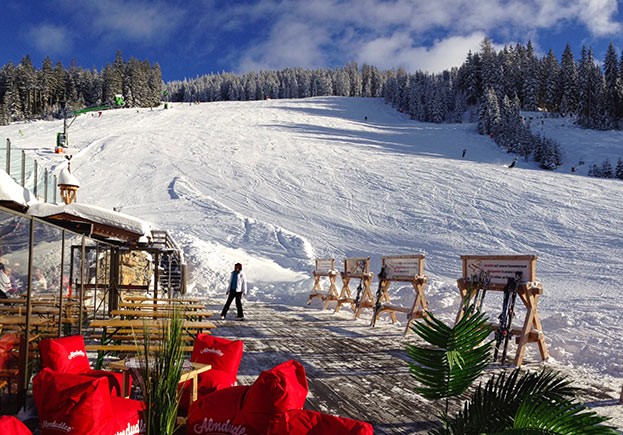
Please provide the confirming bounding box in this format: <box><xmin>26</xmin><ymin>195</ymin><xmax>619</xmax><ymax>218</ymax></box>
<box><xmin>33</xmin><ymin>368</ymin><xmax>144</xmax><ymax>435</ymax></box>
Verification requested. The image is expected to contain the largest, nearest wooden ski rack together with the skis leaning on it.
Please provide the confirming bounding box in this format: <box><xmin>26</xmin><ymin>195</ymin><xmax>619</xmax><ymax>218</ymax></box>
<box><xmin>457</xmin><ymin>255</ymin><xmax>549</xmax><ymax>367</ymax></box>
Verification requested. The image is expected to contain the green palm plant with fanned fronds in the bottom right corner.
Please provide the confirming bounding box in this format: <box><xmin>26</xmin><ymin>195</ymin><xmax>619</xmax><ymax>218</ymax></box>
<box><xmin>407</xmin><ymin>306</ymin><xmax>617</xmax><ymax>435</ymax></box>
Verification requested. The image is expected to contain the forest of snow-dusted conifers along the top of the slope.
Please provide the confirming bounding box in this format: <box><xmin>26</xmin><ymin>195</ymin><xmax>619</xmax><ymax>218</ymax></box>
<box><xmin>0</xmin><ymin>38</ymin><xmax>623</xmax><ymax>175</ymax></box>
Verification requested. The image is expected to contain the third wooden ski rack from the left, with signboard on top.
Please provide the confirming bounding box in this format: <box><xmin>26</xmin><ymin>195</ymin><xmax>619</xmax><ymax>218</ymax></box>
<box><xmin>371</xmin><ymin>254</ymin><xmax>428</xmax><ymax>335</ymax></box>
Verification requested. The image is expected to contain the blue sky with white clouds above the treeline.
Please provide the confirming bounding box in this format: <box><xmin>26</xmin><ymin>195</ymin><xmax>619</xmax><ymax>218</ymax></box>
<box><xmin>0</xmin><ymin>0</ymin><xmax>623</xmax><ymax>81</ymax></box>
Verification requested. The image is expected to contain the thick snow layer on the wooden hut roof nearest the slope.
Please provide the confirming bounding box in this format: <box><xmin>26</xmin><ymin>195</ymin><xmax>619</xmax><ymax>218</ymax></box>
<box><xmin>27</xmin><ymin>203</ymin><xmax>152</xmax><ymax>241</ymax></box>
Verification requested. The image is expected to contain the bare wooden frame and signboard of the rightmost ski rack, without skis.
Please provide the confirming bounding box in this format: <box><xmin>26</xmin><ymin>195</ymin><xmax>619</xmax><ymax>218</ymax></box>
<box><xmin>456</xmin><ymin>255</ymin><xmax>549</xmax><ymax>367</ymax></box>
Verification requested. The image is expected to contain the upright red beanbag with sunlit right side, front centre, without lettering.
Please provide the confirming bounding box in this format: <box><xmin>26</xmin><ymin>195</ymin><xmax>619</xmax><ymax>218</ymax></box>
<box><xmin>236</xmin><ymin>360</ymin><xmax>308</xmax><ymax>433</ymax></box>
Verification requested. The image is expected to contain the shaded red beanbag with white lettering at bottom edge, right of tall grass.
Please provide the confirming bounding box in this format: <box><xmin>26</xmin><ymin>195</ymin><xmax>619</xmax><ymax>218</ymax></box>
<box><xmin>186</xmin><ymin>385</ymin><xmax>253</xmax><ymax>435</ymax></box>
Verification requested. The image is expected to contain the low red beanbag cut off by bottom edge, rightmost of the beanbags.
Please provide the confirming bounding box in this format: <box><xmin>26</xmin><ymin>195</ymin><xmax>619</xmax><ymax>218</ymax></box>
<box><xmin>268</xmin><ymin>409</ymin><xmax>374</xmax><ymax>435</ymax></box>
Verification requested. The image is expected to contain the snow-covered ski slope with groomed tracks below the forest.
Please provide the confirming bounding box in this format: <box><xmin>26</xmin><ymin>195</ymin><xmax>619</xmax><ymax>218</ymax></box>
<box><xmin>1</xmin><ymin>98</ymin><xmax>623</xmax><ymax>384</ymax></box>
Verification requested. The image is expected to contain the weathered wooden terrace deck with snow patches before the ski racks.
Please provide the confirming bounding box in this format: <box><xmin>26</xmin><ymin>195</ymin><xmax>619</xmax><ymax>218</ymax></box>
<box><xmin>208</xmin><ymin>301</ymin><xmax>623</xmax><ymax>435</ymax></box>
